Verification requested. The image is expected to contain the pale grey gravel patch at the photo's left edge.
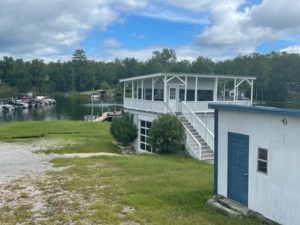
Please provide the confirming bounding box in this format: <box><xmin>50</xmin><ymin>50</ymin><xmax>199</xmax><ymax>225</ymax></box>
<box><xmin>0</xmin><ymin>140</ymin><xmax>61</xmax><ymax>184</ymax></box>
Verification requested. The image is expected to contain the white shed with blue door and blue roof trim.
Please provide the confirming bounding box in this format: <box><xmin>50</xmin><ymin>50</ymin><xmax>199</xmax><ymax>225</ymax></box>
<box><xmin>209</xmin><ymin>104</ymin><xmax>300</xmax><ymax>225</ymax></box>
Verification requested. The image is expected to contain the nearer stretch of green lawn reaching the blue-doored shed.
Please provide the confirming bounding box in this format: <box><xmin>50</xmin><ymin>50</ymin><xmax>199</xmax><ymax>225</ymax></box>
<box><xmin>41</xmin><ymin>155</ymin><xmax>262</xmax><ymax>225</ymax></box>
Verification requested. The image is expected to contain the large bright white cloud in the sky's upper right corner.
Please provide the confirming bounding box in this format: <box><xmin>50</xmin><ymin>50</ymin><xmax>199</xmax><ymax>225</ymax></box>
<box><xmin>195</xmin><ymin>0</ymin><xmax>300</xmax><ymax>56</ymax></box>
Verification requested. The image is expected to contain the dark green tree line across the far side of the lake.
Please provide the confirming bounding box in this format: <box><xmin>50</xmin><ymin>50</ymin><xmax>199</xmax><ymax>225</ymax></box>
<box><xmin>0</xmin><ymin>49</ymin><xmax>300</xmax><ymax>101</ymax></box>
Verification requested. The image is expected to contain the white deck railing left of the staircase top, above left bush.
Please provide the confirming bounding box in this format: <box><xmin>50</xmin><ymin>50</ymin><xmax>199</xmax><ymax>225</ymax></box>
<box><xmin>124</xmin><ymin>98</ymin><xmax>168</xmax><ymax>113</ymax></box>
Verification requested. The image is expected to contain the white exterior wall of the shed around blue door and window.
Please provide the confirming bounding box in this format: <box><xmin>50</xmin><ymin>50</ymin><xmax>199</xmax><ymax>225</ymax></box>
<box><xmin>217</xmin><ymin>110</ymin><xmax>300</xmax><ymax>225</ymax></box>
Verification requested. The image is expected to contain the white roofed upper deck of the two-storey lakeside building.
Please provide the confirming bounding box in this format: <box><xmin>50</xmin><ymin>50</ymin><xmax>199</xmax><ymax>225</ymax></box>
<box><xmin>120</xmin><ymin>73</ymin><xmax>256</xmax><ymax>113</ymax></box>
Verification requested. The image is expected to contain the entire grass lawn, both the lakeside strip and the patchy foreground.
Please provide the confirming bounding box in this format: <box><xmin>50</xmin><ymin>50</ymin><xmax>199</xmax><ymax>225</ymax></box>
<box><xmin>0</xmin><ymin>121</ymin><xmax>262</xmax><ymax>225</ymax></box>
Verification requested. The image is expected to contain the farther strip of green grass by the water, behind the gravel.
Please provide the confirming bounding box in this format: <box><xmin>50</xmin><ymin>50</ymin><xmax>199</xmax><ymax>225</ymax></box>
<box><xmin>0</xmin><ymin>120</ymin><xmax>120</xmax><ymax>154</ymax></box>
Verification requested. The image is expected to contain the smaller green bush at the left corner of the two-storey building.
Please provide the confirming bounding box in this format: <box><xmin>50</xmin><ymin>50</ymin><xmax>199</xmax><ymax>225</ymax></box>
<box><xmin>110</xmin><ymin>112</ymin><xmax>137</xmax><ymax>145</ymax></box>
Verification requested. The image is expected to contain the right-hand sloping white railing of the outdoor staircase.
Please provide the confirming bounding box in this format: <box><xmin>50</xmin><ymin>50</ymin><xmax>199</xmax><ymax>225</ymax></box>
<box><xmin>182</xmin><ymin>102</ymin><xmax>214</xmax><ymax>151</ymax></box>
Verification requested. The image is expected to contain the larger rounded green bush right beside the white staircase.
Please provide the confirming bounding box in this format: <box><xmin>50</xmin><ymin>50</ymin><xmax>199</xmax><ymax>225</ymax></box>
<box><xmin>149</xmin><ymin>114</ymin><xmax>185</xmax><ymax>153</ymax></box>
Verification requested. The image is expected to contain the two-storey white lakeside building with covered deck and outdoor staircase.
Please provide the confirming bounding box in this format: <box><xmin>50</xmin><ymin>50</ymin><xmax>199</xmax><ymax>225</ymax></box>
<box><xmin>120</xmin><ymin>73</ymin><xmax>255</xmax><ymax>162</ymax></box>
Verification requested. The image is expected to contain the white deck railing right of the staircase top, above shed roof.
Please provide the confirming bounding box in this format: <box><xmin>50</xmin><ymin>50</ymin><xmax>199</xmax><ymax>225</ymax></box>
<box><xmin>186</xmin><ymin>100</ymin><xmax>251</xmax><ymax>112</ymax></box>
